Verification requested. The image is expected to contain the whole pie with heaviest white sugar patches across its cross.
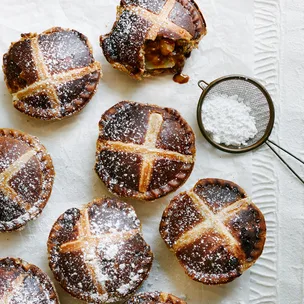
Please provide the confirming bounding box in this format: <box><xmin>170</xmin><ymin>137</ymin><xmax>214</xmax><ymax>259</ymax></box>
<box><xmin>48</xmin><ymin>198</ymin><xmax>153</xmax><ymax>304</ymax></box>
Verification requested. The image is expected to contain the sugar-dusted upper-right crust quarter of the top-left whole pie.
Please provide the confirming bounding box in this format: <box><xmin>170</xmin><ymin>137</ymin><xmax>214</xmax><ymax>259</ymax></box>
<box><xmin>38</xmin><ymin>30</ymin><xmax>94</xmax><ymax>74</ymax></box>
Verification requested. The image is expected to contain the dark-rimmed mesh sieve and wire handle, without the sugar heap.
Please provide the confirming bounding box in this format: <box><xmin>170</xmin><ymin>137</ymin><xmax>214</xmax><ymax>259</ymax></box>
<box><xmin>197</xmin><ymin>75</ymin><xmax>304</xmax><ymax>184</ymax></box>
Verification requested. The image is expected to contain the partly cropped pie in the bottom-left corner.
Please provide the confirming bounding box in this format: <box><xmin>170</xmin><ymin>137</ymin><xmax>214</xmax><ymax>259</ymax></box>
<box><xmin>0</xmin><ymin>258</ymin><xmax>59</xmax><ymax>304</ymax></box>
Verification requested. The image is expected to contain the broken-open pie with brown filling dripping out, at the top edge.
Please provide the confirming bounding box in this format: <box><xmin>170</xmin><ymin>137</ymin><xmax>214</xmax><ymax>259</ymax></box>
<box><xmin>100</xmin><ymin>0</ymin><xmax>206</xmax><ymax>83</ymax></box>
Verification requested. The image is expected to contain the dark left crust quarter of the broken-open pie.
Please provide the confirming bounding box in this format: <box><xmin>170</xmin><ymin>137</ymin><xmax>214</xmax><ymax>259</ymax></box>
<box><xmin>101</xmin><ymin>11</ymin><xmax>152</xmax><ymax>74</ymax></box>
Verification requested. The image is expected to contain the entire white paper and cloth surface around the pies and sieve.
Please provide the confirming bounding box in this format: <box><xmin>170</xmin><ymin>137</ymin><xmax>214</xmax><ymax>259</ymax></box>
<box><xmin>0</xmin><ymin>0</ymin><xmax>304</xmax><ymax>304</ymax></box>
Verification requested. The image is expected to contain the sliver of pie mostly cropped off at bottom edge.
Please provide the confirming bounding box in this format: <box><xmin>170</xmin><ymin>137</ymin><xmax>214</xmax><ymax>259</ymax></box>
<box><xmin>126</xmin><ymin>292</ymin><xmax>187</xmax><ymax>304</ymax></box>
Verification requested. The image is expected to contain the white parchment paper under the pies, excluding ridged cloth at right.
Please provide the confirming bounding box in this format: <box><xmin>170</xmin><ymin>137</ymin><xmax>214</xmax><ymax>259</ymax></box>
<box><xmin>0</xmin><ymin>0</ymin><xmax>274</xmax><ymax>304</ymax></box>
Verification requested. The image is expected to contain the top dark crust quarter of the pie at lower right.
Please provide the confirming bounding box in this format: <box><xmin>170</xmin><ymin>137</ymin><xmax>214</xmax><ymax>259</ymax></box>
<box><xmin>194</xmin><ymin>179</ymin><xmax>247</xmax><ymax>213</ymax></box>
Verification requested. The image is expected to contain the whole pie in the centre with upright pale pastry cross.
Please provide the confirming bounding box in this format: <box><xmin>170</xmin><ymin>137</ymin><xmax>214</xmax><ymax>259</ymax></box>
<box><xmin>95</xmin><ymin>101</ymin><xmax>196</xmax><ymax>200</ymax></box>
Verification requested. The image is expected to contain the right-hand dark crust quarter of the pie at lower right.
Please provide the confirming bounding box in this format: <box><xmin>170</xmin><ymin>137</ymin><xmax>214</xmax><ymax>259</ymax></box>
<box><xmin>226</xmin><ymin>205</ymin><xmax>266</xmax><ymax>262</ymax></box>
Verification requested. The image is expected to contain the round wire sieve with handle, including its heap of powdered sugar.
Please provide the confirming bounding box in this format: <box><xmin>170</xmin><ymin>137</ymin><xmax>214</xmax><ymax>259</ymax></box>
<box><xmin>197</xmin><ymin>75</ymin><xmax>304</xmax><ymax>184</ymax></box>
